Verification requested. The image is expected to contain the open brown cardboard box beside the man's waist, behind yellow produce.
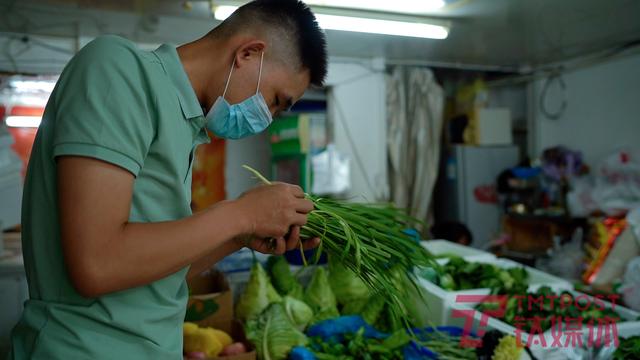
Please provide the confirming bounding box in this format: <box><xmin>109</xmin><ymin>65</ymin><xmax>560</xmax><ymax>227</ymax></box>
<box><xmin>185</xmin><ymin>271</ymin><xmax>256</xmax><ymax>360</ymax></box>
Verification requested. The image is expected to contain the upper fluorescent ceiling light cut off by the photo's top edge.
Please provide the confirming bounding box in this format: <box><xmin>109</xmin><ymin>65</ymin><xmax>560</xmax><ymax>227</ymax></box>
<box><xmin>304</xmin><ymin>0</ymin><xmax>446</xmax><ymax>14</ymax></box>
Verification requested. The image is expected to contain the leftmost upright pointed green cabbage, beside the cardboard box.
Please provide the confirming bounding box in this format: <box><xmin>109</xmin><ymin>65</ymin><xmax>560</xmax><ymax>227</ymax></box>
<box><xmin>236</xmin><ymin>262</ymin><xmax>282</xmax><ymax>320</ymax></box>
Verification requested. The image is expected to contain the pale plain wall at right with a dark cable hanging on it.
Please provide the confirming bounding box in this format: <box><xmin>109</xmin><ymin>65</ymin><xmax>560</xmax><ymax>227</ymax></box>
<box><xmin>529</xmin><ymin>55</ymin><xmax>640</xmax><ymax>165</ymax></box>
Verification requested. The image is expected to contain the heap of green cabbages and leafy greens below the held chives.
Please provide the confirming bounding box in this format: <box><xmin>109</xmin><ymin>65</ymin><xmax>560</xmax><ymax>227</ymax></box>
<box><xmin>236</xmin><ymin>257</ymin><xmax>470</xmax><ymax>360</ymax></box>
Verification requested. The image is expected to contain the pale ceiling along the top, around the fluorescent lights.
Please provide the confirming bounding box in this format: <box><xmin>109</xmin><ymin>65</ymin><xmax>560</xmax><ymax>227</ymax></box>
<box><xmin>0</xmin><ymin>0</ymin><xmax>640</xmax><ymax>69</ymax></box>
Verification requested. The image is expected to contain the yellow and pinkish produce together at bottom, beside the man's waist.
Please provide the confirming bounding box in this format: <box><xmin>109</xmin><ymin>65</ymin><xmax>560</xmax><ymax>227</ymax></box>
<box><xmin>182</xmin><ymin>322</ymin><xmax>247</xmax><ymax>359</ymax></box>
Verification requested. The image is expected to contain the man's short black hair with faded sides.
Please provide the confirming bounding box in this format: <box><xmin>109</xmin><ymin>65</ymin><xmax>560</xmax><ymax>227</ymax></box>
<box><xmin>216</xmin><ymin>0</ymin><xmax>327</xmax><ymax>86</ymax></box>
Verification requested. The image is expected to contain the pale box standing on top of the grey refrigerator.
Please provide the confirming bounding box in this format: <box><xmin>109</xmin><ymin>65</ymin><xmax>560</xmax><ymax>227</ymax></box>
<box><xmin>477</xmin><ymin>108</ymin><xmax>513</xmax><ymax>145</ymax></box>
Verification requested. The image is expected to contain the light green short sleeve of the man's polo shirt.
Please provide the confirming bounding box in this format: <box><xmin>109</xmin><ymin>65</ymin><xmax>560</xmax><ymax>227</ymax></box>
<box><xmin>53</xmin><ymin>36</ymin><xmax>155</xmax><ymax>176</ymax></box>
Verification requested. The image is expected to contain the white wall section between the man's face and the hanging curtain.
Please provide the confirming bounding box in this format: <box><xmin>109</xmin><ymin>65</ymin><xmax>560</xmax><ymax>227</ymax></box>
<box><xmin>327</xmin><ymin>59</ymin><xmax>389</xmax><ymax>201</ymax></box>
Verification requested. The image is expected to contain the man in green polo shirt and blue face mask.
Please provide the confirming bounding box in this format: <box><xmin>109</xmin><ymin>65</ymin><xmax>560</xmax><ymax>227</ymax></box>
<box><xmin>11</xmin><ymin>0</ymin><xmax>327</xmax><ymax>359</ymax></box>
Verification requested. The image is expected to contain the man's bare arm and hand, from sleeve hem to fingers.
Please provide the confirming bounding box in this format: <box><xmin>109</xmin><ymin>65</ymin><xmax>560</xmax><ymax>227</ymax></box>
<box><xmin>57</xmin><ymin>156</ymin><xmax>313</xmax><ymax>297</ymax></box>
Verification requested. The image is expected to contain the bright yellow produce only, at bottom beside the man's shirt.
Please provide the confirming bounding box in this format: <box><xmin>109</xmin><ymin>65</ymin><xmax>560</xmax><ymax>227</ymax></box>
<box><xmin>182</xmin><ymin>322</ymin><xmax>233</xmax><ymax>358</ymax></box>
